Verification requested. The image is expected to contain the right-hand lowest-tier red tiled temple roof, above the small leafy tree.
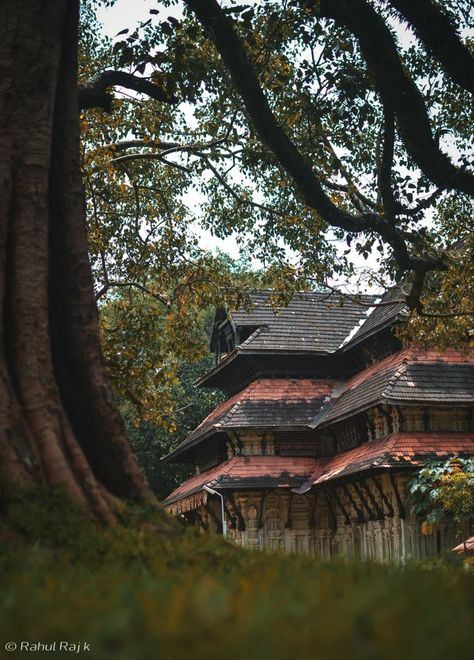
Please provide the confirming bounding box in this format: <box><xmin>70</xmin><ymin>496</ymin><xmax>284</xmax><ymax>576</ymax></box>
<box><xmin>311</xmin><ymin>433</ymin><xmax>474</xmax><ymax>485</ymax></box>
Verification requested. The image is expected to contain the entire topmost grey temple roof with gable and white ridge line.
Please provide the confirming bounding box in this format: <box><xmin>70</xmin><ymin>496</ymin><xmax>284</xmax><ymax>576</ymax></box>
<box><xmin>196</xmin><ymin>289</ymin><xmax>406</xmax><ymax>385</ymax></box>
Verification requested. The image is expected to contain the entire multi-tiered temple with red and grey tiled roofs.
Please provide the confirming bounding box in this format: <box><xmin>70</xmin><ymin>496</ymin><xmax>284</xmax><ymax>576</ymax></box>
<box><xmin>164</xmin><ymin>291</ymin><xmax>474</xmax><ymax>561</ymax></box>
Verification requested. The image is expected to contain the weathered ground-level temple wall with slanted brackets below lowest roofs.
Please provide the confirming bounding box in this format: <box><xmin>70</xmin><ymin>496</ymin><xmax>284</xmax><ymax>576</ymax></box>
<box><xmin>185</xmin><ymin>474</ymin><xmax>458</xmax><ymax>563</ymax></box>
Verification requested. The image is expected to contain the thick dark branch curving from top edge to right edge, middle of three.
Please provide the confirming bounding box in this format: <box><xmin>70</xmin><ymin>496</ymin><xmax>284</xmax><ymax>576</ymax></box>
<box><xmin>311</xmin><ymin>0</ymin><xmax>474</xmax><ymax>195</ymax></box>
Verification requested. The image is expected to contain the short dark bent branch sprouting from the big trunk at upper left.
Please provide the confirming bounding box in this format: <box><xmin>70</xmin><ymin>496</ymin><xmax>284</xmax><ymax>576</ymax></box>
<box><xmin>78</xmin><ymin>69</ymin><xmax>178</xmax><ymax>112</ymax></box>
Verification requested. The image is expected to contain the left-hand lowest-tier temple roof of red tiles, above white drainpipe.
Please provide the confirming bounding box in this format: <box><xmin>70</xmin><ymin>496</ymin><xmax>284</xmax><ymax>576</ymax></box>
<box><xmin>163</xmin><ymin>456</ymin><xmax>317</xmax><ymax>506</ymax></box>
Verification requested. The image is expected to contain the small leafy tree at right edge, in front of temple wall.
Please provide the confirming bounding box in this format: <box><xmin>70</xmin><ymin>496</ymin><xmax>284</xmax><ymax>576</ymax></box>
<box><xmin>409</xmin><ymin>458</ymin><xmax>474</xmax><ymax>552</ymax></box>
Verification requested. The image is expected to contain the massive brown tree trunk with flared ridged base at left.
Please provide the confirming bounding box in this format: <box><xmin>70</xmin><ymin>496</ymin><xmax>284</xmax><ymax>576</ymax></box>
<box><xmin>0</xmin><ymin>0</ymin><xmax>153</xmax><ymax>520</ymax></box>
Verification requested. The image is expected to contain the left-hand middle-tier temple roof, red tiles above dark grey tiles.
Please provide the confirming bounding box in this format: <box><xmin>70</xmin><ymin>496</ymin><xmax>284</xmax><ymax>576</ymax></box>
<box><xmin>168</xmin><ymin>378</ymin><xmax>334</xmax><ymax>458</ymax></box>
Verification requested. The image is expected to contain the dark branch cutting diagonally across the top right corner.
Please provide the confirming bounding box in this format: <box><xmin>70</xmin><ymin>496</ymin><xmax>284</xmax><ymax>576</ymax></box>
<box><xmin>389</xmin><ymin>0</ymin><xmax>474</xmax><ymax>94</ymax></box>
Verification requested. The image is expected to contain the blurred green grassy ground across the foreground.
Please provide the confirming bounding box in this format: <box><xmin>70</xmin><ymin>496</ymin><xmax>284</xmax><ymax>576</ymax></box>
<box><xmin>0</xmin><ymin>494</ymin><xmax>474</xmax><ymax>660</ymax></box>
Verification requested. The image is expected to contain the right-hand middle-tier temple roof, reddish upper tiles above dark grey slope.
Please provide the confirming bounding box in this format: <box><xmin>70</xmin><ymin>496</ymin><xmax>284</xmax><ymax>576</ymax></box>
<box><xmin>312</xmin><ymin>349</ymin><xmax>474</xmax><ymax>428</ymax></box>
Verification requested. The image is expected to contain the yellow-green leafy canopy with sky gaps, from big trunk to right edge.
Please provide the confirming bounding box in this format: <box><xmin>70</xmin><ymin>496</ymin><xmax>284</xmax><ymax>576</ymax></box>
<box><xmin>80</xmin><ymin>0</ymin><xmax>474</xmax><ymax>426</ymax></box>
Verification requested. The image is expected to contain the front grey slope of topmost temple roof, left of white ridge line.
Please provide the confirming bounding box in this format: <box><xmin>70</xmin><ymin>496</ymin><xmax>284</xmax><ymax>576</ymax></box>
<box><xmin>231</xmin><ymin>291</ymin><xmax>374</xmax><ymax>353</ymax></box>
